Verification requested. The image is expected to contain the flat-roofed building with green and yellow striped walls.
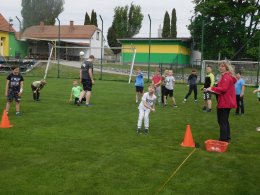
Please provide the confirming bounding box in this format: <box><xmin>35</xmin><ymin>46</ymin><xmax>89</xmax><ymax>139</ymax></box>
<box><xmin>118</xmin><ymin>38</ymin><xmax>191</xmax><ymax>65</ymax></box>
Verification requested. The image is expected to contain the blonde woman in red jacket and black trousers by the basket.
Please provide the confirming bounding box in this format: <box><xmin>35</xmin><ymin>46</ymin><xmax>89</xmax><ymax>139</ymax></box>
<box><xmin>206</xmin><ymin>60</ymin><xmax>237</xmax><ymax>142</ymax></box>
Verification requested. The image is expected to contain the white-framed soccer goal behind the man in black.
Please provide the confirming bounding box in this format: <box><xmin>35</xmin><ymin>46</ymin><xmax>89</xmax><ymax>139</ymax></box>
<box><xmin>44</xmin><ymin>45</ymin><xmax>136</xmax><ymax>83</ymax></box>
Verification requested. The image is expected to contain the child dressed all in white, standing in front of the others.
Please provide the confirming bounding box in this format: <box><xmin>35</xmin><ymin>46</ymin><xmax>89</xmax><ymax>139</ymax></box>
<box><xmin>137</xmin><ymin>85</ymin><xmax>156</xmax><ymax>134</ymax></box>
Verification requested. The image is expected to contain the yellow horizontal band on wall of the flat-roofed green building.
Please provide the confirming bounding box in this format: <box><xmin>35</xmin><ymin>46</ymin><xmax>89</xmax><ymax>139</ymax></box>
<box><xmin>123</xmin><ymin>45</ymin><xmax>190</xmax><ymax>55</ymax></box>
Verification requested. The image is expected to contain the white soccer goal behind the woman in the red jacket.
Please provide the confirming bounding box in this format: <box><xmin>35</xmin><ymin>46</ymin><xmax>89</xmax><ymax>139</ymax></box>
<box><xmin>201</xmin><ymin>60</ymin><xmax>259</xmax><ymax>86</ymax></box>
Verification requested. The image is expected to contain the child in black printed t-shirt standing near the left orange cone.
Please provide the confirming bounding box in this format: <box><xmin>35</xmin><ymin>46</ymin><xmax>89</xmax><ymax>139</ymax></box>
<box><xmin>5</xmin><ymin>66</ymin><xmax>24</xmax><ymax>116</ymax></box>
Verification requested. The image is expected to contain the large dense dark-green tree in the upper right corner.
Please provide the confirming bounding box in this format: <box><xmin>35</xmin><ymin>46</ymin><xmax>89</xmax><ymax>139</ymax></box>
<box><xmin>189</xmin><ymin>0</ymin><xmax>260</xmax><ymax>60</ymax></box>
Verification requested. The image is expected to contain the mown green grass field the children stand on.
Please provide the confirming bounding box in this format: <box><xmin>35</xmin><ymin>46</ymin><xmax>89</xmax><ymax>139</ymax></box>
<box><xmin>0</xmin><ymin>66</ymin><xmax>260</xmax><ymax>195</ymax></box>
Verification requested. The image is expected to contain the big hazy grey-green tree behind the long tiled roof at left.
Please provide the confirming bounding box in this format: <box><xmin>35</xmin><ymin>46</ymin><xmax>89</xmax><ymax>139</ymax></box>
<box><xmin>21</xmin><ymin>0</ymin><xmax>64</xmax><ymax>28</ymax></box>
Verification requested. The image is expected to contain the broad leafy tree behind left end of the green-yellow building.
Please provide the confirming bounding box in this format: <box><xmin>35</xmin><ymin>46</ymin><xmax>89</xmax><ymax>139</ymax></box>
<box><xmin>107</xmin><ymin>3</ymin><xmax>143</xmax><ymax>54</ymax></box>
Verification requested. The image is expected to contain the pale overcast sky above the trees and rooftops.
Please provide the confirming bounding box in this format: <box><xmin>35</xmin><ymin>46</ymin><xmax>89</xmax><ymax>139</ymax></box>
<box><xmin>0</xmin><ymin>0</ymin><xmax>194</xmax><ymax>37</ymax></box>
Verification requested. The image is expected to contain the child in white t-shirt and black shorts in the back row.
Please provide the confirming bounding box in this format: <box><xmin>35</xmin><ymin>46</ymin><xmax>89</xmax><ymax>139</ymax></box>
<box><xmin>164</xmin><ymin>70</ymin><xmax>177</xmax><ymax>108</ymax></box>
